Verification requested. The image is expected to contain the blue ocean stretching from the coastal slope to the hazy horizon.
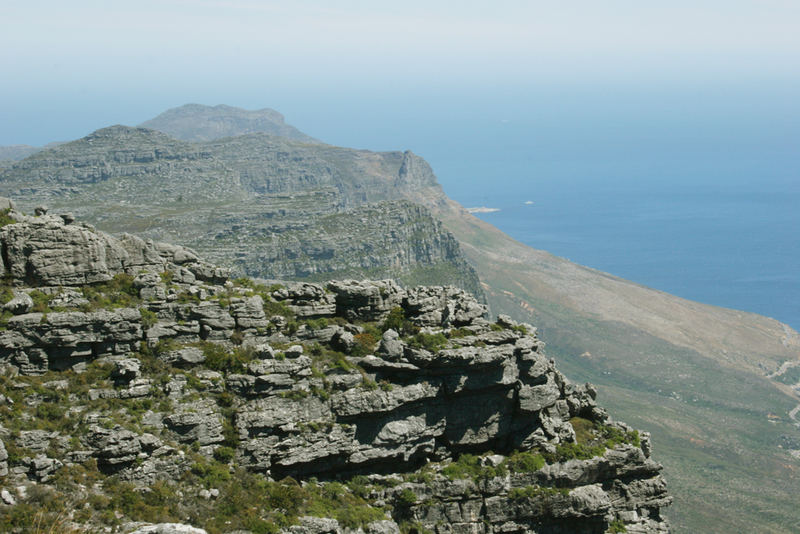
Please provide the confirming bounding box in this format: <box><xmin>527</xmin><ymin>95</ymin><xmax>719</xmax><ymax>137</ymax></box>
<box><xmin>276</xmin><ymin>83</ymin><xmax>800</xmax><ymax>330</ymax></box>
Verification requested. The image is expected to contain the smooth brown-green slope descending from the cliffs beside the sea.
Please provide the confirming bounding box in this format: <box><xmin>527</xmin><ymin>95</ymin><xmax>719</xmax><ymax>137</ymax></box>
<box><xmin>438</xmin><ymin>202</ymin><xmax>800</xmax><ymax>533</ymax></box>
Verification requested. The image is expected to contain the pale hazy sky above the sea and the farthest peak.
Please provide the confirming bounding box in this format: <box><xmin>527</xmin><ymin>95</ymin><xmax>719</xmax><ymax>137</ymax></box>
<box><xmin>0</xmin><ymin>0</ymin><xmax>800</xmax><ymax>144</ymax></box>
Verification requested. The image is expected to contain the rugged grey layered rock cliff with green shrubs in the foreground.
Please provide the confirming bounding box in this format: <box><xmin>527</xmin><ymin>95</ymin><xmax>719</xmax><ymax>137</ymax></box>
<box><xmin>0</xmin><ymin>206</ymin><xmax>671</xmax><ymax>534</ymax></box>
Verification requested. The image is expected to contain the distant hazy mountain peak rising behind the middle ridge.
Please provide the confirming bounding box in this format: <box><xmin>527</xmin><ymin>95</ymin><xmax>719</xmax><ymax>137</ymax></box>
<box><xmin>139</xmin><ymin>104</ymin><xmax>319</xmax><ymax>143</ymax></box>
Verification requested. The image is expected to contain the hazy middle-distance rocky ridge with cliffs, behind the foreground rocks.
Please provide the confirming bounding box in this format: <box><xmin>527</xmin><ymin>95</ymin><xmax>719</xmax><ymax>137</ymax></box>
<box><xmin>0</xmin><ymin>126</ymin><xmax>482</xmax><ymax>298</ymax></box>
